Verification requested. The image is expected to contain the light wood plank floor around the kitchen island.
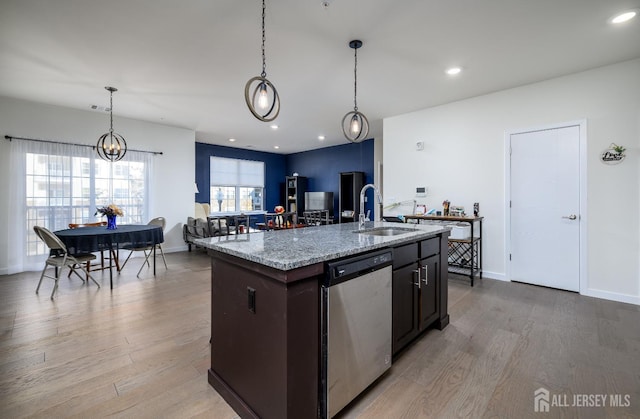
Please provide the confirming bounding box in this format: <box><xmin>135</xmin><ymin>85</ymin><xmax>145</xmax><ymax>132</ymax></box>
<box><xmin>0</xmin><ymin>251</ymin><xmax>640</xmax><ymax>419</ymax></box>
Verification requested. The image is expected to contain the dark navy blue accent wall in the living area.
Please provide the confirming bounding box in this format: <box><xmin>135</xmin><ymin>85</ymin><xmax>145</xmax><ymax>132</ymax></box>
<box><xmin>195</xmin><ymin>139</ymin><xmax>375</xmax><ymax>218</ymax></box>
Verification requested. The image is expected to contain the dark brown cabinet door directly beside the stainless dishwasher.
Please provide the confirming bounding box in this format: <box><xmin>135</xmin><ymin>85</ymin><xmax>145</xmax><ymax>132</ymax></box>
<box><xmin>393</xmin><ymin>262</ymin><xmax>419</xmax><ymax>354</ymax></box>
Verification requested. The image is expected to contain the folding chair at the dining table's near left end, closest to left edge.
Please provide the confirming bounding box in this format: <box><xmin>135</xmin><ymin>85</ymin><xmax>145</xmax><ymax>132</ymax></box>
<box><xmin>33</xmin><ymin>226</ymin><xmax>100</xmax><ymax>300</ymax></box>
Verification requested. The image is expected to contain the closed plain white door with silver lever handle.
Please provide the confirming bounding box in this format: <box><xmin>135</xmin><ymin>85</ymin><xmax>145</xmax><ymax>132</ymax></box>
<box><xmin>509</xmin><ymin>125</ymin><xmax>581</xmax><ymax>291</ymax></box>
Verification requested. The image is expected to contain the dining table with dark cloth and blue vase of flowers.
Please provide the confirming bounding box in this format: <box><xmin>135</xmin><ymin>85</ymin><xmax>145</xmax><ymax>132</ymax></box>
<box><xmin>54</xmin><ymin>204</ymin><xmax>167</xmax><ymax>289</ymax></box>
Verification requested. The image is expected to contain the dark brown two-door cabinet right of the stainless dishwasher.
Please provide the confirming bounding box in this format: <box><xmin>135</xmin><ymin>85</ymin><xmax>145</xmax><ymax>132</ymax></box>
<box><xmin>392</xmin><ymin>237</ymin><xmax>448</xmax><ymax>355</ymax></box>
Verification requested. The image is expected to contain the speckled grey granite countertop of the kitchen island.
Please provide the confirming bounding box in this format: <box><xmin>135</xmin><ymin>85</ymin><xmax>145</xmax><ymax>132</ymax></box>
<box><xmin>195</xmin><ymin>221</ymin><xmax>451</xmax><ymax>271</ymax></box>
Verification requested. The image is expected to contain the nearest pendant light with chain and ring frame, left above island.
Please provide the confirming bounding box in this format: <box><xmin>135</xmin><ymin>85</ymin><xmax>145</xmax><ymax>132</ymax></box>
<box><xmin>244</xmin><ymin>0</ymin><xmax>280</xmax><ymax>122</ymax></box>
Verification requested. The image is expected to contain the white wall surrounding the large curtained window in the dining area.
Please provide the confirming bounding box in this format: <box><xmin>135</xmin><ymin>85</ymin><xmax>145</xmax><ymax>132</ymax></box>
<box><xmin>0</xmin><ymin>97</ymin><xmax>195</xmax><ymax>273</ymax></box>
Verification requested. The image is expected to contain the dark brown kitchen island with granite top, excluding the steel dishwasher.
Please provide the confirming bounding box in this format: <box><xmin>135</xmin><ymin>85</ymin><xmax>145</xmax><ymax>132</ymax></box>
<box><xmin>198</xmin><ymin>222</ymin><xmax>449</xmax><ymax>418</ymax></box>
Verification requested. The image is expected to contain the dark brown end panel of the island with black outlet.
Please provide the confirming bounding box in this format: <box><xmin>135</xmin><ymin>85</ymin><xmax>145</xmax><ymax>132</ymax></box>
<box><xmin>209</xmin><ymin>254</ymin><xmax>319</xmax><ymax>418</ymax></box>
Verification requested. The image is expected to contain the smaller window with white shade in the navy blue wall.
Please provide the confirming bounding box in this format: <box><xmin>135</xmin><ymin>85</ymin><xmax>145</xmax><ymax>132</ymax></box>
<box><xmin>209</xmin><ymin>156</ymin><xmax>264</xmax><ymax>212</ymax></box>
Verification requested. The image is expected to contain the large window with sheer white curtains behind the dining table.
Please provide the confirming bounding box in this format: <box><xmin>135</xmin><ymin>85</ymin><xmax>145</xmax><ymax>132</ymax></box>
<box><xmin>8</xmin><ymin>141</ymin><xmax>152</xmax><ymax>272</ymax></box>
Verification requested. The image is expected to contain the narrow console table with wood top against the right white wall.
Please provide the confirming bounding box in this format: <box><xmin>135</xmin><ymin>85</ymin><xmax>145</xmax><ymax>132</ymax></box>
<box><xmin>404</xmin><ymin>215</ymin><xmax>484</xmax><ymax>286</ymax></box>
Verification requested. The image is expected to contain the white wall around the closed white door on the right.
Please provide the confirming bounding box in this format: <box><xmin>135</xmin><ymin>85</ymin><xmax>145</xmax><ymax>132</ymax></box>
<box><xmin>383</xmin><ymin>60</ymin><xmax>640</xmax><ymax>304</ymax></box>
